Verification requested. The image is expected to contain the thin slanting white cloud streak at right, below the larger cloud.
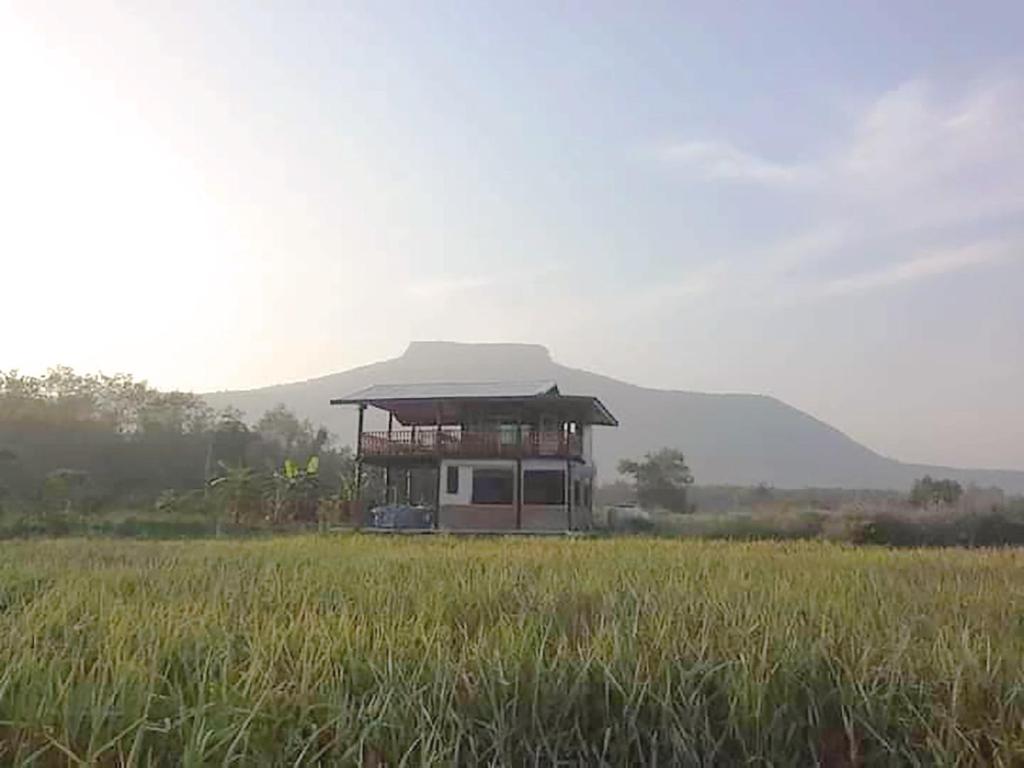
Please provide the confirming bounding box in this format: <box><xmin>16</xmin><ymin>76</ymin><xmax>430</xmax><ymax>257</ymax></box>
<box><xmin>822</xmin><ymin>243</ymin><xmax>1019</xmax><ymax>295</ymax></box>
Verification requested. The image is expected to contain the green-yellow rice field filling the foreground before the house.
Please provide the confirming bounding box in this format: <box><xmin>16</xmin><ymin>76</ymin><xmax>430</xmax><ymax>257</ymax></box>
<box><xmin>0</xmin><ymin>535</ymin><xmax>1024</xmax><ymax>766</ymax></box>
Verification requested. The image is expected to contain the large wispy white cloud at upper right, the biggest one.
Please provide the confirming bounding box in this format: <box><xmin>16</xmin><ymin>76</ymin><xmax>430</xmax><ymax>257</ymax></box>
<box><xmin>664</xmin><ymin>80</ymin><xmax>1024</xmax><ymax>228</ymax></box>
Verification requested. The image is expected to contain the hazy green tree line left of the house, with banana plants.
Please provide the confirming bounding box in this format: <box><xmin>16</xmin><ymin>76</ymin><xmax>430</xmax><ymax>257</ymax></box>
<box><xmin>0</xmin><ymin>368</ymin><xmax>354</xmax><ymax>522</ymax></box>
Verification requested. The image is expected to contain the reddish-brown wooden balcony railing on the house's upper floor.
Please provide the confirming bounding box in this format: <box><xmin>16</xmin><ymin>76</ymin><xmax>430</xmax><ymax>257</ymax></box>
<box><xmin>360</xmin><ymin>427</ymin><xmax>583</xmax><ymax>461</ymax></box>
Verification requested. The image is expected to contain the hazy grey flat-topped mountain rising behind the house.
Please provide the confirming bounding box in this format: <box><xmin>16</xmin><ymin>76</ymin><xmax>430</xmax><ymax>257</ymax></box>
<box><xmin>204</xmin><ymin>341</ymin><xmax>1024</xmax><ymax>493</ymax></box>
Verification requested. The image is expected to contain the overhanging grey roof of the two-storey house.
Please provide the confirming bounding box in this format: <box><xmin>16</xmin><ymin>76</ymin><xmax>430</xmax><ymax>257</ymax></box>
<box><xmin>331</xmin><ymin>381</ymin><xmax>618</xmax><ymax>426</ymax></box>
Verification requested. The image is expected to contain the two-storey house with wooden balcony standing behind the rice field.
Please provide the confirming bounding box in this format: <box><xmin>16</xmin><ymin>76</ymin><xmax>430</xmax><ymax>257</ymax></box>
<box><xmin>331</xmin><ymin>381</ymin><xmax>618</xmax><ymax>531</ymax></box>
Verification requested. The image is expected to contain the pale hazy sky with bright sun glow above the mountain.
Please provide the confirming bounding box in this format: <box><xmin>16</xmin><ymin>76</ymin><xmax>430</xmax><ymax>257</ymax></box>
<box><xmin>0</xmin><ymin>0</ymin><xmax>1024</xmax><ymax>469</ymax></box>
